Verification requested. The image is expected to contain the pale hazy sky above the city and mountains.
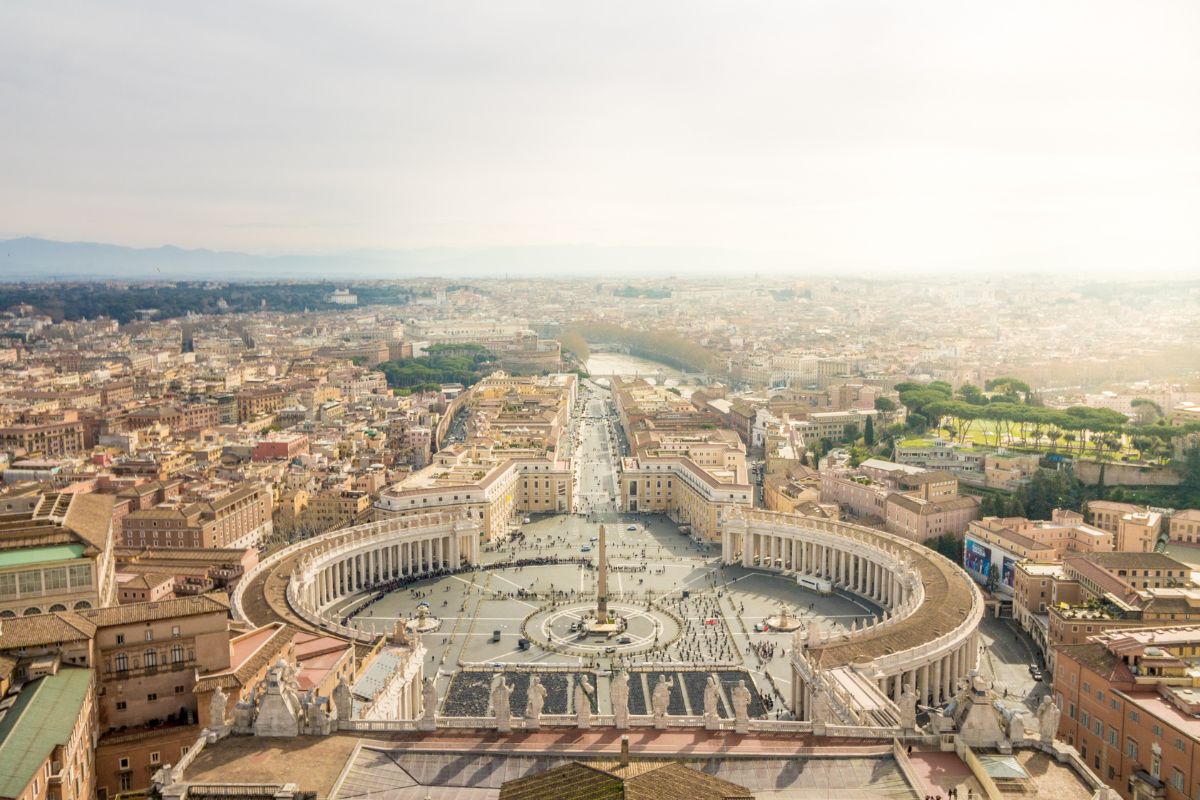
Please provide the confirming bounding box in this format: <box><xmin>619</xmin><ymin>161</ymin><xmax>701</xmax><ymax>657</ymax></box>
<box><xmin>0</xmin><ymin>0</ymin><xmax>1200</xmax><ymax>275</ymax></box>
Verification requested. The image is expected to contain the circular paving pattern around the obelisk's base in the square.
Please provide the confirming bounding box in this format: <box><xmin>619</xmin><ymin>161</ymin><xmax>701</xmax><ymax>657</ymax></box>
<box><xmin>522</xmin><ymin>601</ymin><xmax>682</xmax><ymax>656</ymax></box>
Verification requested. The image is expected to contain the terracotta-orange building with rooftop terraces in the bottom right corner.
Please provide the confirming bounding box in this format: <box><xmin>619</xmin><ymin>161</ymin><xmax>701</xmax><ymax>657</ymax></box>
<box><xmin>1054</xmin><ymin>625</ymin><xmax>1200</xmax><ymax>800</ymax></box>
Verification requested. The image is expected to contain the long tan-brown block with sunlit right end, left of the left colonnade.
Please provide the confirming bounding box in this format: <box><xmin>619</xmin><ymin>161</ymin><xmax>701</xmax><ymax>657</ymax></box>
<box><xmin>121</xmin><ymin>483</ymin><xmax>272</xmax><ymax>548</ymax></box>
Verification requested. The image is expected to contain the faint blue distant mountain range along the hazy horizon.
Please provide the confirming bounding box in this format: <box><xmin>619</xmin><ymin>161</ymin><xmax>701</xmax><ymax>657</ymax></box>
<box><xmin>0</xmin><ymin>237</ymin><xmax>768</xmax><ymax>282</ymax></box>
